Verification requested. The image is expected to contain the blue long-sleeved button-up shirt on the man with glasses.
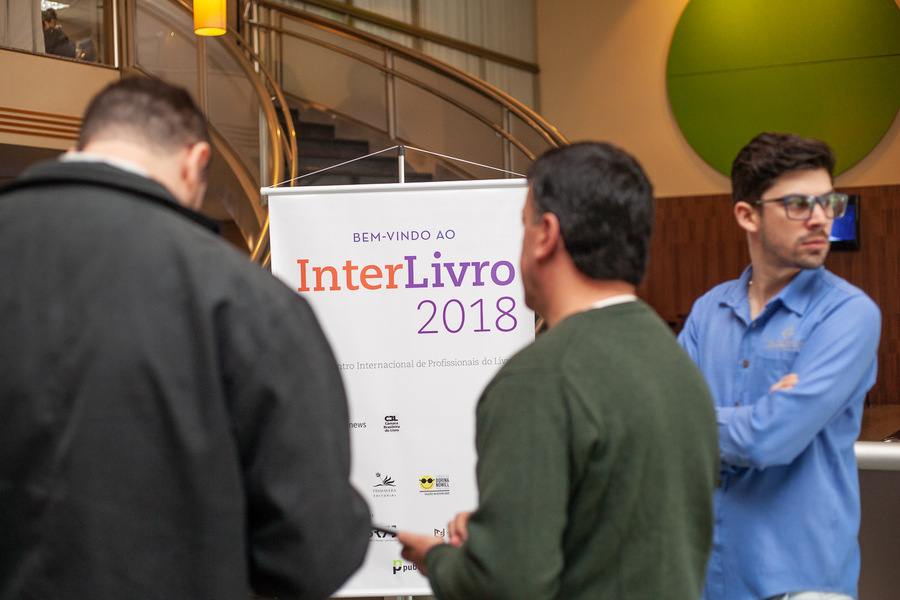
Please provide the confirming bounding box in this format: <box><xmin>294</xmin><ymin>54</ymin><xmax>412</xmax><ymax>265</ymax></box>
<box><xmin>678</xmin><ymin>267</ymin><xmax>881</xmax><ymax>600</ymax></box>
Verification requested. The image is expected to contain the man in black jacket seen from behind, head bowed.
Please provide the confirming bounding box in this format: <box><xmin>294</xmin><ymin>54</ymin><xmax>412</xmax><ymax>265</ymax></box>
<box><xmin>0</xmin><ymin>79</ymin><xmax>370</xmax><ymax>600</ymax></box>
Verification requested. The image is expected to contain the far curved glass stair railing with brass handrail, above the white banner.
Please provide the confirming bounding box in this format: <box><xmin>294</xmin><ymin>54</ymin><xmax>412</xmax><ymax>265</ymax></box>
<box><xmin>244</xmin><ymin>0</ymin><xmax>566</xmax><ymax>179</ymax></box>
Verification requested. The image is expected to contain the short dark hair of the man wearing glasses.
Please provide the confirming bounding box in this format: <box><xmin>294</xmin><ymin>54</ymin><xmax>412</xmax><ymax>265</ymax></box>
<box><xmin>731</xmin><ymin>133</ymin><xmax>835</xmax><ymax>203</ymax></box>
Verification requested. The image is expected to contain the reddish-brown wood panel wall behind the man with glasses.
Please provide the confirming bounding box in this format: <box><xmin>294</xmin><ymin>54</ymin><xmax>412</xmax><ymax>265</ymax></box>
<box><xmin>638</xmin><ymin>186</ymin><xmax>900</xmax><ymax>405</ymax></box>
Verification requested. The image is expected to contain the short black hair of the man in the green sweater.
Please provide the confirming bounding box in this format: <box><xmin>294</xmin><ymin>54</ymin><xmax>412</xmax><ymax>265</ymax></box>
<box><xmin>527</xmin><ymin>142</ymin><xmax>654</xmax><ymax>285</ymax></box>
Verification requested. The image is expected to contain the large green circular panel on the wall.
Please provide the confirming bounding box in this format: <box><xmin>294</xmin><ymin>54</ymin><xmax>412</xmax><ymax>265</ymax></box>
<box><xmin>666</xmin><ymin>0</ymin><xmax>900</xmax><ymax>175</ymax></box>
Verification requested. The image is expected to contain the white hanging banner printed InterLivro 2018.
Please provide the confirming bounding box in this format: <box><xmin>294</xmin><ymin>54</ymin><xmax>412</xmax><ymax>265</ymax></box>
<box><xmin>266</xmin><ymin>180</ymin><xmax>534</xmax><ymax>597</ymax></box>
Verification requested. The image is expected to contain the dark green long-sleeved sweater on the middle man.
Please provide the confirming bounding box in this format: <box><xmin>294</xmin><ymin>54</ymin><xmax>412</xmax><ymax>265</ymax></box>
<box><xmin>426</xmin><ymin>302</ymin><xmax>719</xmax><ymax>600</ymax></box>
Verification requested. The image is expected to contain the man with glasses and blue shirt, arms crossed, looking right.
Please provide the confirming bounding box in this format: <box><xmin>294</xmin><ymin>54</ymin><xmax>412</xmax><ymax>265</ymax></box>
<box><xmin>678</xmin><ymin>133</ymin><xmax>881</xmax><ymax>600</ymax></box>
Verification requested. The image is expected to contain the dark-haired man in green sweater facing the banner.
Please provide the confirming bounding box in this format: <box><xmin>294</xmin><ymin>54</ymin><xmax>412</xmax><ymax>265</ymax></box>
<box><xmin>398</xmin><ymin>143</ymin><xmax>719</xmax><ymax>600</ymax></box>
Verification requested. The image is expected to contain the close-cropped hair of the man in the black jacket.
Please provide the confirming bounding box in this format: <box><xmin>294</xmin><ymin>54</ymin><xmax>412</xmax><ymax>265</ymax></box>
<box><xmin>77</xmin><ymin>77</ymin><xmax>210</xmax><ymax>151</ymax></box>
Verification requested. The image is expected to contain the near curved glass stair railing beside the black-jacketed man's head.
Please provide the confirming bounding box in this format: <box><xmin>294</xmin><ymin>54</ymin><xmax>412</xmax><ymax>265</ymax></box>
<box><xmin>126</xmin><ymin>0</ymin><xmax>296</xmax><ymax>254</ymax></box>
